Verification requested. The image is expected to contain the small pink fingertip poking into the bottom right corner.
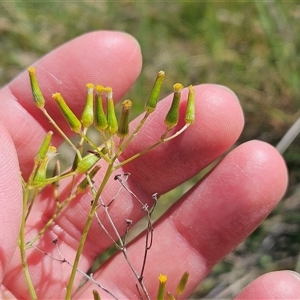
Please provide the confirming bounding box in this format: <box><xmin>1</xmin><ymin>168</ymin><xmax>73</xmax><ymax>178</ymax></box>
<box><xmin>234</xmin><ymin>271</ymin><xmax>300</xmax><ymax>300</ymax></box>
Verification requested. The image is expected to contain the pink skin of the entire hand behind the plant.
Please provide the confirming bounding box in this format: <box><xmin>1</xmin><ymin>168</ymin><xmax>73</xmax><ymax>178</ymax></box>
<box><xmin>0</xmin><ymin>31</ymin><xmax>300</xmax><ymax>299</ymax></box>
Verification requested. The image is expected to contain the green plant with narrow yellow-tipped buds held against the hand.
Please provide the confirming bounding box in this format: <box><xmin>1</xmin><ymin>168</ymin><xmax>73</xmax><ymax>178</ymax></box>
<box><xmin>19</xmin><ymin>67</ymin><xmax>195</xmax><ymax>300</ymax></box>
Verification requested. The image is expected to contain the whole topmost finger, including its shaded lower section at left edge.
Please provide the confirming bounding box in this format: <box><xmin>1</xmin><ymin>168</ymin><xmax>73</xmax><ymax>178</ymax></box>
<box><xmin>0</xmin><ymin>31</ymin><xmax>141</xmax><ymax>174</ymax></box>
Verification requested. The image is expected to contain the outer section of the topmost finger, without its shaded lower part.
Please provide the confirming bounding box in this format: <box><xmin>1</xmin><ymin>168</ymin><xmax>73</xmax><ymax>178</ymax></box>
<box><xmin>9</xmin><ymin>31</ymin><xmax>142</xmax><ymax>113</ymax></box>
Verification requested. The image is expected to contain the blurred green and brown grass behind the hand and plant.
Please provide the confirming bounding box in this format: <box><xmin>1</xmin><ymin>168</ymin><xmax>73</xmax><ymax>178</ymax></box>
<box><xmin>0</xmin><ymin>0</ymin><xmax>300</xmax><ymax>299</ymax></box>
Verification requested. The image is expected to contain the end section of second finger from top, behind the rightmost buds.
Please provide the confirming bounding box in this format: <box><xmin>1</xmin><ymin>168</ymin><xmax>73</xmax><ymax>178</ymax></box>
<box><xmin>120</xmin><ymin>84</ymin><xmax>244</xmax><ymax>195</ymax></box>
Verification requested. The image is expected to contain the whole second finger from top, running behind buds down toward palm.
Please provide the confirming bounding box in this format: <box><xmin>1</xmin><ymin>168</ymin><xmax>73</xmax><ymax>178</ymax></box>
<box><xmin>4</xmin><ymin>85</ymin><xmax>243</xmax><ymax>297</ymax></box>
